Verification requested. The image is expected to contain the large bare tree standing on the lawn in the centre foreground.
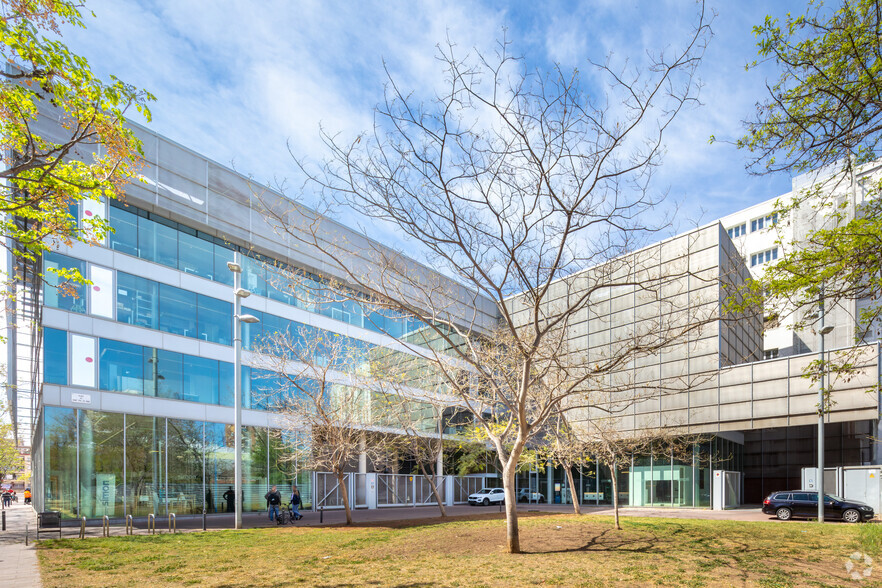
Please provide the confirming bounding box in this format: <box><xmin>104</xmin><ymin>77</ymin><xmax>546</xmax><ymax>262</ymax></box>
<box><xmin>263</xmin><ymin>6</ymin><xmax>709</xmax><ymax>553</ymax></box>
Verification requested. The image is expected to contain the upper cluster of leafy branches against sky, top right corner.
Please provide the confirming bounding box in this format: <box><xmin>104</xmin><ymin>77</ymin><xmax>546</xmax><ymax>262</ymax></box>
<box><xmin>737</xmin><ymin>0</ymin><xmax>882</xmax><ymax>173</ymax></box>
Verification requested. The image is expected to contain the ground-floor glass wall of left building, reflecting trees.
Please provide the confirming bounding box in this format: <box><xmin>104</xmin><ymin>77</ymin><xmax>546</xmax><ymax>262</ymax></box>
<box><xmin>44</xmin><ymin>406</ymin><xmax>312</xmax><ymax>518</ymax></box>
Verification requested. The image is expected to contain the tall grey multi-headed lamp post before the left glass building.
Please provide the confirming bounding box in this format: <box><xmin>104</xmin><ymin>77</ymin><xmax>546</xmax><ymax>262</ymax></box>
<box><xmin>227</xmin><ymin>252</ymin><xmax>259</xmax><ymax>529</ymax></box>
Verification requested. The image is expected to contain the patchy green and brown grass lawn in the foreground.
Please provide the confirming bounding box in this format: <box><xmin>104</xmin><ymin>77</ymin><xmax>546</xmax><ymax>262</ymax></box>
<box><xmin>39</xmin><ymin>514</ymin><xmax>882</xmax><ymax>587</ymax></box>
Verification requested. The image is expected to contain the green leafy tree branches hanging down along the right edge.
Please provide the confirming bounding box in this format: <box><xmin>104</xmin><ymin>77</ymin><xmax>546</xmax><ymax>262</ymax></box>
<box><xmin>737</xmin><ymin>0</ymin><xmax>882</xmax><ymax>372</ymax></box>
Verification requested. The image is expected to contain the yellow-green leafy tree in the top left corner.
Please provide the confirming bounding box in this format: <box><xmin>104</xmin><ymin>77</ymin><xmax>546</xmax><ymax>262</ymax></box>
<box><xmin>0</xmin><ymin>0</ymin><xmax>153</xmax><ymax>279</ymax></box>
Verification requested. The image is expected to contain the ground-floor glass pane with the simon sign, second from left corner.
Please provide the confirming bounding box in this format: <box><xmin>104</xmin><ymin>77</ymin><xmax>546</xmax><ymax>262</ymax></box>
<box><xmin>79</xmin><ymin>410</ymin><xmax>125</xmax><ymax>518</ymax></box>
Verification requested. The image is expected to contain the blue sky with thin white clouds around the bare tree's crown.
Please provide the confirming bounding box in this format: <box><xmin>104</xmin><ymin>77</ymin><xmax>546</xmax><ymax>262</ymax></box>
<box><xmin>65</xmin><ymin>0</ymin><xmax>805</xmax><ymax>238</ymax></box>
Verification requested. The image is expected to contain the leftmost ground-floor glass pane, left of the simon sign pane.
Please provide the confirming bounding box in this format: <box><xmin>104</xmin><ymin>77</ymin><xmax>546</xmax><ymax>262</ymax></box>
<box><xmin>43</xmin><ymin>406</ymin><xmax>77</xmax><ymax>518</ymax></box>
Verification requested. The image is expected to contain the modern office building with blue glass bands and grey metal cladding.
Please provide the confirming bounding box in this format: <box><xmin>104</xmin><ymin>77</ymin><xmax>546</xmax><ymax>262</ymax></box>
<box><xmin>7</xmin><ymin>119</ymin><xmax>879</xmax><ymax>517</ymax></box>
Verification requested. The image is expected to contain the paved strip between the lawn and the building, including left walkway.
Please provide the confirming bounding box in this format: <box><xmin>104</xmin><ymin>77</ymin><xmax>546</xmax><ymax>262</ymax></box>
<box><xmin>0</xmin><ymin>504</ymin><xmax>792</xmax><ymax>588</ymax></box>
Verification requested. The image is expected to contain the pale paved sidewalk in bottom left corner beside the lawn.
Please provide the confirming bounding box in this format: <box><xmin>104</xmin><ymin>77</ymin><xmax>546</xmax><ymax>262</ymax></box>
<box><xmin>0</xmin><ymin>503</ymin><xmax>40</xmax><ymax>588</ymax></box>
